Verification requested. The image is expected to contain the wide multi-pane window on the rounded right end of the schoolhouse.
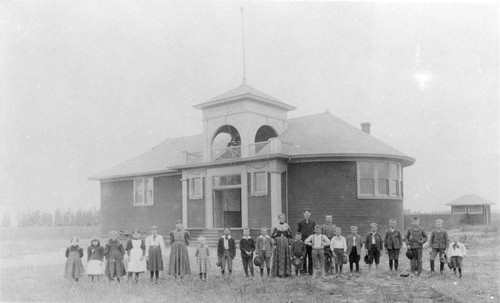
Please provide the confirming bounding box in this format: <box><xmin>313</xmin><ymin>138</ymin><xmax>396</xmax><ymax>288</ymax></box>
<box><xmin>356</xmin><ymin>160</ymin><xmax>403</xmax><ymax>200</ymax></box>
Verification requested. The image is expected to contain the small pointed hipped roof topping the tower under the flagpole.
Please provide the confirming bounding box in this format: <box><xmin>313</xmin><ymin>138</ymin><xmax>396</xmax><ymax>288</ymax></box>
<box><xmin>193</xmin><ymin>81</ymin><xmax>296</xmax><ymax>111</ymax></box>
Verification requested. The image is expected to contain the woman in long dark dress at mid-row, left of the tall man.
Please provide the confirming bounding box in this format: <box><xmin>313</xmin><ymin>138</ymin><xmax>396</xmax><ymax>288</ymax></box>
<box><xmin>271</xmin><ymin>214</ymin><xmax>292</xmax><ymax>278</ymax></box>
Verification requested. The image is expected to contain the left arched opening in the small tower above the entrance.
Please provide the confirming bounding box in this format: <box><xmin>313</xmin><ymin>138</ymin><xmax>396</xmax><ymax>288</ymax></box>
<box><xmin>212</xmin><ymin>125</ymin><xmax>241</xmax><ymax>161</ymax></box>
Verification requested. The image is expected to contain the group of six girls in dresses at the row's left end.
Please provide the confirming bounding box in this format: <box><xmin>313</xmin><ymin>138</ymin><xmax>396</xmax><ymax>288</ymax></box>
<box><xmin>65</xmin><ymin>221</ymin><xmax>193</xmax><ymax>283</ymax></box>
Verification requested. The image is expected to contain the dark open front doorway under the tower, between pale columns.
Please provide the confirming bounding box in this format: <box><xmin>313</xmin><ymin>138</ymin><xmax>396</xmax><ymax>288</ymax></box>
<box><xmin>213</xmin><ymin>188</ymin><xmax>242</xmax><ymax>228</ymax></box>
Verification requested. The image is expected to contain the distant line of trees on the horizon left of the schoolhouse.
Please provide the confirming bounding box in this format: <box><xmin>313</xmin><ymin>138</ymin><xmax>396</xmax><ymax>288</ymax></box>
<box><xmin>1</xmin><ymin>209</ymin><xmax>100</xmax><ymax>227</ymax></box>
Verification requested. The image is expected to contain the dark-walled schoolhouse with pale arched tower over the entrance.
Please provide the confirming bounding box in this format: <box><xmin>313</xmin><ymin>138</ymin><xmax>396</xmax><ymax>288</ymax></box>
<box><xmin>91</xmin><ymin>82</ymin><xmax>415</xmax><ymax>240</ymax></box>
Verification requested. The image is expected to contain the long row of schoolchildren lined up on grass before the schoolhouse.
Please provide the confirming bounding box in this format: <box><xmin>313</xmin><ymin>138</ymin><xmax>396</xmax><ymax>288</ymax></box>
<box><xmin>65</xmin><ymin>216</ymin><xmax>466</xmax><ymax>283</ymax></box>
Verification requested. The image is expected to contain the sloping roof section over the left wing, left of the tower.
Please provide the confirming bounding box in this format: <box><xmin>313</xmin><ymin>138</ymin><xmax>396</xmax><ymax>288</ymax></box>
<box><xmin>90</xmin><ymin>134</ymin><xmax>203</xmax><ymax>180</ymax></box>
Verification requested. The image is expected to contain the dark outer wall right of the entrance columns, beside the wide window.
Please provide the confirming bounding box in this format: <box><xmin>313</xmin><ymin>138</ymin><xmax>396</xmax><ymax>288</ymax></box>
<box><xmin>288</xmin><ymin>162</ymin><xmax>403</xmax><ymax>236</ymax></box>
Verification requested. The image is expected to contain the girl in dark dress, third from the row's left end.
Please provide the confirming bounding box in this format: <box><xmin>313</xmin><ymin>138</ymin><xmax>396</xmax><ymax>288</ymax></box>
<box><xmin>104</xmin><ymin>231</ymin><xmax>127</xmax><ymax>283</ymax></box>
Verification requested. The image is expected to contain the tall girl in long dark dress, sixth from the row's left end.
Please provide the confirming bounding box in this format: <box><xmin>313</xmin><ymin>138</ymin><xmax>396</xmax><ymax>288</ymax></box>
<box><xmin>168</xmin><ymin>220</ymin><xmax>191</xmax><ymax>278</ymax></box>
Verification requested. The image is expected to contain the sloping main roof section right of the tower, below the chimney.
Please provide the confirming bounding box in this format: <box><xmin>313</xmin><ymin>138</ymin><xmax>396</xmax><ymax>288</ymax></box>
<box><xmin>280</xmin><ymin>112</ymin><xmax>415</xmax><ymax>166</ymax></box>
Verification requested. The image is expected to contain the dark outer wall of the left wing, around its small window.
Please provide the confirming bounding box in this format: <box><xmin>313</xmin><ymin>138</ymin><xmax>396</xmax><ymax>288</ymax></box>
<box><xmin>101</xmin><ymin>175</ymin><xmax>182</xmax><ymax>236</ymax></box>
